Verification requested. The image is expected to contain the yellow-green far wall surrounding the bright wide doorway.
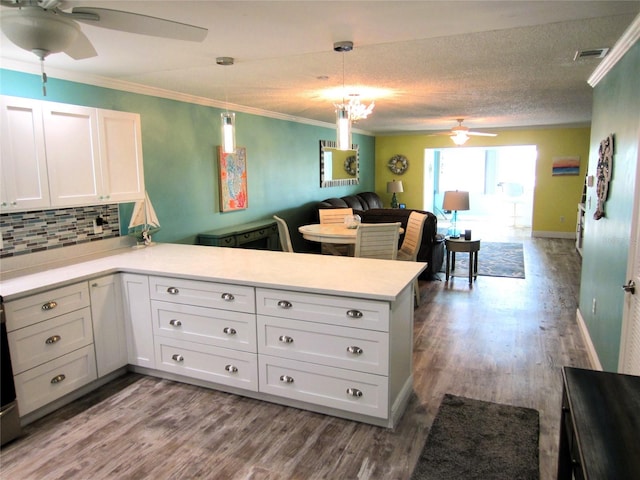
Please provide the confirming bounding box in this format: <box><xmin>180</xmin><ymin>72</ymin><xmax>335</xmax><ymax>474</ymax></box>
<box><xmin>375</xmin><ymin>127</ymin><xmax>590</xmax><ymax>236</ymax></box>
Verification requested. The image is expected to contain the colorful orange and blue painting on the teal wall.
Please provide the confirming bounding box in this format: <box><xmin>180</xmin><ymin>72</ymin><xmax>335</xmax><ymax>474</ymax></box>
<box><xmin>218</xmin><ymin>147</ymin><xmax>248</xmax><ymax>212</ymax></box>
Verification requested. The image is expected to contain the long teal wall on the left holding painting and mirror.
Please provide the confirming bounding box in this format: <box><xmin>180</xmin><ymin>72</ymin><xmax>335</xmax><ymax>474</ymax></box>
<box><xmin>0</xmin><ymin>70</ymin><xmax>375</xmax><ymax>249</ymax></box>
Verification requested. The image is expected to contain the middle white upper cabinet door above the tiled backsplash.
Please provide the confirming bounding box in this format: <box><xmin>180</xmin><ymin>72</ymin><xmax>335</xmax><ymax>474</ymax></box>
<box><xmin>42</xmin><ymin>102</ymin><xmax>102</xmax><ymax>207</ymax></box>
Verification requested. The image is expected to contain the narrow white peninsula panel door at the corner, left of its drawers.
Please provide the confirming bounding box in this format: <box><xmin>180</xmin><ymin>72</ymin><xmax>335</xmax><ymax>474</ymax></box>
<box><xmin>120</xmin><ymin>273</ymin><xmax>156</xmax><ymax>368</ymax></box>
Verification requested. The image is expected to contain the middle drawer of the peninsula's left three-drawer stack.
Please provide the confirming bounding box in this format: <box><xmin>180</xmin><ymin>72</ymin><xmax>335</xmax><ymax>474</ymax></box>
<box><xmin>151</xmin><ymin>300</ymin><xmax>257</xmax><ymax>353</ymax></box>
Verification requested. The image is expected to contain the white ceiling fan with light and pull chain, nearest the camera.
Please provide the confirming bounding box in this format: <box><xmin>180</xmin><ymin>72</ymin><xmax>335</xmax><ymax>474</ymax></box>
<box><xmin>0</xmin><ymin>0</ymin><xmax>208</xmax><ymax>61</ymax></box>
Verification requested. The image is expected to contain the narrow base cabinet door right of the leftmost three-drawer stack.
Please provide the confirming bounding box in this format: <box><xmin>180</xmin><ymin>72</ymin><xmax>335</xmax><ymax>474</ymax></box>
<box><xmin>89</xmin><ymin>275</ymin><xmax>128</xmax><ymax>377</ymax></box>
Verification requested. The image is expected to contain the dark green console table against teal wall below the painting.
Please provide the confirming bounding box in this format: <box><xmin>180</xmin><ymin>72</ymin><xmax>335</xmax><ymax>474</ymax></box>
<box><xmin>198</xmin><ymin>219</ymin><xmax>280</xmax><ymax>250</ymax></box>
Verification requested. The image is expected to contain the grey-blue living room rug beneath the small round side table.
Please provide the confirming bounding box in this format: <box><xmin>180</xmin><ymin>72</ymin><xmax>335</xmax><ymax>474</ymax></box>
<box><xmin>441</xmin><ymin>242</ymin><xmax>524</xmax><ymax>278</ymax></box>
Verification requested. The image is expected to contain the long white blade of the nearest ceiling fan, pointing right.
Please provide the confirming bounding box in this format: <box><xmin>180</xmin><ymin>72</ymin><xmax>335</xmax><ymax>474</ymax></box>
<box><xmin>71</xmin><ymin>7</ymin><xmax>209</xmax><ymax>42</ymax></box>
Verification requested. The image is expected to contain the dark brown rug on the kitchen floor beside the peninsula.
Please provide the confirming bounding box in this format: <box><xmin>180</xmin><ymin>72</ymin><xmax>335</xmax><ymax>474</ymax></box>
<box><xmin>411</xmin><ymin>393</ymin><xmax>540</xmax><ymax>480</ymax></box>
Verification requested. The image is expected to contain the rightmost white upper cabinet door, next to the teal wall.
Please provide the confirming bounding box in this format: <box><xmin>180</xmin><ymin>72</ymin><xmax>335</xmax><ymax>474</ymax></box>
<box><xmin>98</xmin><ymin>110</ymin><xmax>144</xmax><ymax>202</ymax></box>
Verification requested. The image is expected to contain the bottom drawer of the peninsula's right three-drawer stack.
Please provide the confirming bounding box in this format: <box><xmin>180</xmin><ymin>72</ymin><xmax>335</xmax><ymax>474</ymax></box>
<box><xmin>259</xmin><ymin>355</ymin><xmax>389</xmax><ymax>419</ymax></box>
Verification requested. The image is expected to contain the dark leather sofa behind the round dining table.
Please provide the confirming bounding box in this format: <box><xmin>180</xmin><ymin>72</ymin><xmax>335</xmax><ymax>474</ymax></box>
<box><xmin>315</xmin><ymin>192</ymin><xmax>444</xmax><ymax>280</ymax></box>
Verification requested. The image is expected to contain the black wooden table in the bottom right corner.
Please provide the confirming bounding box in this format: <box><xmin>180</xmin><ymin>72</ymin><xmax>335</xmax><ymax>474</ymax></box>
<box><xmin>558</xmin><ymin>367</ymin><xmax>640</xmax><ymax>480</ymax></box>
